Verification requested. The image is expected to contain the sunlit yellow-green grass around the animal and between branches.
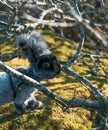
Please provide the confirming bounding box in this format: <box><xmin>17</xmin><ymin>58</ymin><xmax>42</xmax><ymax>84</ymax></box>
<box><xmin>0</xmin><ymin>31</ymin><xmax>108</xmax><ymax>130</ymax></box>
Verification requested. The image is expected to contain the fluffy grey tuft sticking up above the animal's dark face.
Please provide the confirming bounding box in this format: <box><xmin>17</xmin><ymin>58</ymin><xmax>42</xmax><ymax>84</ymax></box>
<box><xmin>16</xmin><ymin>31</ymin><xmax>50</xmax><ymax>62</ymax></box>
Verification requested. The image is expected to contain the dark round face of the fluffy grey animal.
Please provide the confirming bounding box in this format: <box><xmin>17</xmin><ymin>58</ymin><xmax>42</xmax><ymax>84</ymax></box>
<box><xmin>33</xmin><ymin>55</ymin><xmax>61</xmax><ymax>79</ymax></box>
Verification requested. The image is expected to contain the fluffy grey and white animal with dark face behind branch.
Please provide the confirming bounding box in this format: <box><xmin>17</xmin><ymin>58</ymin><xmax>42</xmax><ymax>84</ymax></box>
<box><xmin>0</xmin><ymin>31</ymin><xmax>60</xmax><ymax>114</ymax></box>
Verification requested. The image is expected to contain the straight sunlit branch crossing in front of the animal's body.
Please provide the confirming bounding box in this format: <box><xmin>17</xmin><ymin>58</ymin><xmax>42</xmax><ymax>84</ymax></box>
<box><xmin>0</xmin><ymin>61</ymin><xmax>68</xmax><ymax>107</ymax></box>
